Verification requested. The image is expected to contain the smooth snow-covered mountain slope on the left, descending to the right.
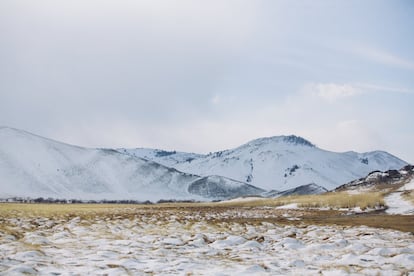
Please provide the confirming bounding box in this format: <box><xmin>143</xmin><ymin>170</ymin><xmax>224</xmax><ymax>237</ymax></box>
<box><xmin>0</xmin><ymin>127</ymin><xmax>263</xmax><ymax>201</ymax></box>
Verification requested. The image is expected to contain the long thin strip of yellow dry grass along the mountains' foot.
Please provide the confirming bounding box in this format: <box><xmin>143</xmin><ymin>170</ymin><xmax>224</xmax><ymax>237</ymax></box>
<box><xmin>0</xmin><ymin>192</ymin><xmax>386</xmax><ymax>218</ymax></box>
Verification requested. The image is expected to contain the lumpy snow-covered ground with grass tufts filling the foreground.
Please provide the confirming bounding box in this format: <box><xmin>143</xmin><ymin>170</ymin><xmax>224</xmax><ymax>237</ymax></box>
<box><xmin>0</xmin><ymin>208</ymin><xmax>414</xmax><ymax>275</ymax></box>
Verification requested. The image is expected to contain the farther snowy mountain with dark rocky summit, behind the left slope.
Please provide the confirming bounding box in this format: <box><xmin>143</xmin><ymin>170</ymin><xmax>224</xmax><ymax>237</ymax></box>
<box><xmin>118</xmin><ymin>135</ymin><xmax>407</xmax><ymax>191</ymax></box>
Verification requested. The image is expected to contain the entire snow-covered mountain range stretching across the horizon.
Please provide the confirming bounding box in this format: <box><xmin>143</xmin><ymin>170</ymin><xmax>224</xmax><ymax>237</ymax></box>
<box><xmin>0</xmin><ymin>127</ymin><xmax>407</xmax><ymax>201</ymax></box>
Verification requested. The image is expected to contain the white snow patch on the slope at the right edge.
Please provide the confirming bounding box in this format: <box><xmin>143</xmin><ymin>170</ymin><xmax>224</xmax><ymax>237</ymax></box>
<box><xmin>384</xmin><ymin>180</ymin><xmax>414</xmax><ymax>215</ymax></box>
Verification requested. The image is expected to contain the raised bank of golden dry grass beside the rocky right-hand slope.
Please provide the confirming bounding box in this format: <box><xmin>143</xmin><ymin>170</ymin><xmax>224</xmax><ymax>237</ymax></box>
<box><xmin>217</xmin><ymin>192</ymin><xmax>385</xmax><ymax>210</ymax></box>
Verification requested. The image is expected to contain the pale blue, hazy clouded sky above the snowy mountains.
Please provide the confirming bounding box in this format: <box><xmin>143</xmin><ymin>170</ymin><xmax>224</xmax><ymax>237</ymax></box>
<box><xmin>0</xmin><ymin>0</ymin><xmax>414</xmax><ymax>163</ymax></box>
